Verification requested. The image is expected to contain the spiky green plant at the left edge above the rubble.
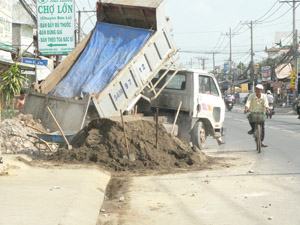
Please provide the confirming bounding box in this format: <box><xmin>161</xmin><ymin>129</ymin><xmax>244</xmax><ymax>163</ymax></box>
<box><xmin>0</xmin><ymin>64</ymin><xmax>26</xmax><ymax>105</ymax></box>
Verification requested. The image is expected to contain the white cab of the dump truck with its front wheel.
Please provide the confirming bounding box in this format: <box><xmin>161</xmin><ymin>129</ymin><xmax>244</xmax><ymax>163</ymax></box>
<box><xmin>152</xmin><ymin>69</ymin><xmax>225</xmax><ymax>149</ymax></box>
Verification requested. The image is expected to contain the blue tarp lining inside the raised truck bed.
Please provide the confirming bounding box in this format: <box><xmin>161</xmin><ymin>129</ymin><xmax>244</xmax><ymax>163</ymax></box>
<box><xmin>51</xmin><ymin>22</ymin><xmax>153</xmax><ymax>98</ymax></box>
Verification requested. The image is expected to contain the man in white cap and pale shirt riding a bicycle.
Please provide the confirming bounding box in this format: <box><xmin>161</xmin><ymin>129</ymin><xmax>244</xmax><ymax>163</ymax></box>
<box><xmin>245</xmin><ymin>84</ymin><xmax>269</xmax><ymax>147</ymax></box>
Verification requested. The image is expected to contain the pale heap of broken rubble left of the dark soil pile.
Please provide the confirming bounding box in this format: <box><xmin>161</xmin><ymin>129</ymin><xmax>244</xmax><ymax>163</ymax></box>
<box><xmin>0</xmin><ymin>114</ymin><xmax>48</xmax><ymax>154</ymax></box>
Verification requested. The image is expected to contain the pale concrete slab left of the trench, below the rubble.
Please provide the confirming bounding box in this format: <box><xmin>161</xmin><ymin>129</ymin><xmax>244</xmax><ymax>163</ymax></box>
<box><xmin>0</xmin><ymin>155</ymin><xmax>111</xmax><ymax>225</ymax></box>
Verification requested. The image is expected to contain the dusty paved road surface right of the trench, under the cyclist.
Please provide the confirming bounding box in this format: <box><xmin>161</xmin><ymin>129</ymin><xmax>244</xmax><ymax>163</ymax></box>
<box><xmin>121</xmin><ymin>112</ymin><xmax>300</xmax><ymax>225</ymax></box>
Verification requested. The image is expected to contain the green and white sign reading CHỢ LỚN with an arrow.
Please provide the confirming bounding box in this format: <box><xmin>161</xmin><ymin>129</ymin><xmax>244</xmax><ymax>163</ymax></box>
<box><xmin>37</xmin><ymin>0</ymin><xmax>75</xmax><ymax>55</ymax></box>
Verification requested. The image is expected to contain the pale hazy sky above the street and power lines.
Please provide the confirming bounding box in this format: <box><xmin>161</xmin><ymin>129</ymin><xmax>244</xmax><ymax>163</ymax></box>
<box><xmin>76</xmin><ymin>0</ymin><xmax>300</xmax><ymax>69</ymax></box>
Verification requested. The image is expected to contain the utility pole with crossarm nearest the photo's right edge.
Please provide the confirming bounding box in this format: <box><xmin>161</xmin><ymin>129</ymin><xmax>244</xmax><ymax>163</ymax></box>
<box><xmin>280</xmin><ymin>0</ymin><xmax>300</xmax><ymax>98</ymax></box>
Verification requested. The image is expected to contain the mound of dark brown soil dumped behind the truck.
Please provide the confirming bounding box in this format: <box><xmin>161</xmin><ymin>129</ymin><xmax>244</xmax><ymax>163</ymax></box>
<box><xmin>46</xmin><ymin>119</ymin><xmax>208</xmax><ymax>171</ymax></box>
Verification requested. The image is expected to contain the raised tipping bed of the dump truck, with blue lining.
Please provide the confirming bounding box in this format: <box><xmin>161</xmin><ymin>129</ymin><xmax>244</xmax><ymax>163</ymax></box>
<box><xmin>25</xmin><ymin>0</ymin><xmax>177</xmax><ymax>133</ymax></box>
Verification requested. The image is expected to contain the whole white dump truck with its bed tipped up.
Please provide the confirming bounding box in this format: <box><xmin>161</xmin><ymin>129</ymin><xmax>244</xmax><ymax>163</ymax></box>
<box><xmin>25</xmin><ymin>0</ymin><xmax>225</xmax><ymax>149</ymax></box>
